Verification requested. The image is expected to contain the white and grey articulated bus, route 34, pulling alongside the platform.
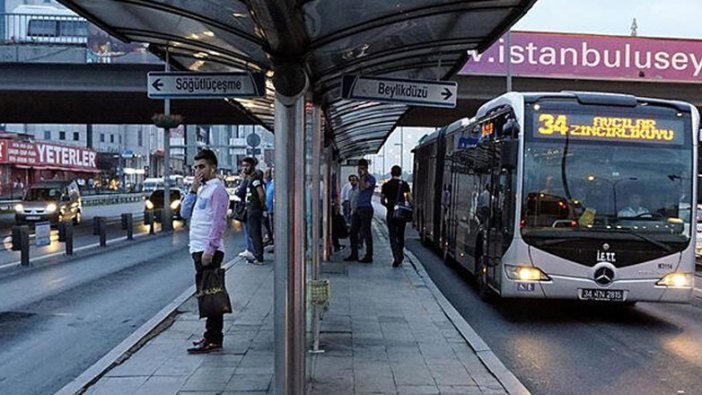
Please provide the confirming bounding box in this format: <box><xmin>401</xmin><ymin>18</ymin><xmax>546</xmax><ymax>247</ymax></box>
<box><xmin>414</xmin><ymin>92</ymin><xmax>699</xmax><ymax>303</ymax></box>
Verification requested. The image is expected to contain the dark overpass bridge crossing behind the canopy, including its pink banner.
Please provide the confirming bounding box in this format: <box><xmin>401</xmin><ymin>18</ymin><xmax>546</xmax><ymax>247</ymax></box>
<box><xmin>0</xmin><ymin>32</ymin><xmax>702</xmax><ymax>127</ymax></box>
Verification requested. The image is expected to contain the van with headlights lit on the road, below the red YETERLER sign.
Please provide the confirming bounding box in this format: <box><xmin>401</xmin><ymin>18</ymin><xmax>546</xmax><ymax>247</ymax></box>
<box><xmin>15</xmin><ymin>181</ymin><xmax>83</xmax><ymax>225</ymax></box>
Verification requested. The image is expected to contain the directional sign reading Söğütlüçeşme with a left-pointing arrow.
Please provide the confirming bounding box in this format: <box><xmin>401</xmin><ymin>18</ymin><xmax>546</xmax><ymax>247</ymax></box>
<box><xmin>147</xmin><ymin>72</ymin><xmax>266</xmax><ymax>99</ymax></box>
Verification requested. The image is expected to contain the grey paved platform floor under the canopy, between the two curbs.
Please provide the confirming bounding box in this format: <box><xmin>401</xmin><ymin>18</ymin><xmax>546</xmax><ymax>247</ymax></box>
<box><xmin>85</xmin><ymin>222</ymin><xmax>507</xmax><ymax>395</ymax></box>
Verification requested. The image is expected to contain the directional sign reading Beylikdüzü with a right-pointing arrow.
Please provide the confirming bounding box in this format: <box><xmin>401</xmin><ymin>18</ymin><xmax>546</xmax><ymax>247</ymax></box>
<box><xmin>341</xmin><ymin>75</ymin><xmax>458</xmax><ymax>108</ymax></box>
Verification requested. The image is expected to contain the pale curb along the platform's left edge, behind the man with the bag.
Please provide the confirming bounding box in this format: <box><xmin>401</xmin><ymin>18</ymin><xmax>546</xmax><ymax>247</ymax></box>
<box><xmin>54</xmin><ymin>257</ymin><xmax>244</xmax><ymax>395</ymax></box>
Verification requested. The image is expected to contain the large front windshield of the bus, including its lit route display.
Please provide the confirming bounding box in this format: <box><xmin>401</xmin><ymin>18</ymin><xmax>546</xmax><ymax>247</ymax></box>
<box><xmin>520</xmin><ymin>104</ymin><xmax>694</xmax><ymax>250</ymax></box>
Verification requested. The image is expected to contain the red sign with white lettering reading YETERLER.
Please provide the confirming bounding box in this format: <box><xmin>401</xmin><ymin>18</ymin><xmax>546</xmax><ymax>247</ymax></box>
<box><xmin>0</xmin><ymin>140</ymin><xmax>97</xmax><ymax>171</ymax></box>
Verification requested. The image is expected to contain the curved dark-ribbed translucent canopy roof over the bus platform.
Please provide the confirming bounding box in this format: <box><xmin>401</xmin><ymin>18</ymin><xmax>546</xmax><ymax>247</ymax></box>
<box><xmin>60</xmin><ymin>0</ymin><xmax>536</xmax><ymax>158</ymax></box>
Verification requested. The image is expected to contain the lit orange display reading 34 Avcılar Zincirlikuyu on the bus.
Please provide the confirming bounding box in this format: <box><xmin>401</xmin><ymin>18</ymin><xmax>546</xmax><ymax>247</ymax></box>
<box><xmin>534</xmin><ymin>112</ymin><xmax>684</xmax><ymax>145</ymax></box>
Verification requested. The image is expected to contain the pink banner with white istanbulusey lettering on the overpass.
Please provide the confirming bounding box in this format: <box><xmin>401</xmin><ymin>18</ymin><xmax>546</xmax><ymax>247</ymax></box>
<box><xmin>459</xmin><ymin>32</ymin><xmax>702</xmax><ymax>83</ymax></box>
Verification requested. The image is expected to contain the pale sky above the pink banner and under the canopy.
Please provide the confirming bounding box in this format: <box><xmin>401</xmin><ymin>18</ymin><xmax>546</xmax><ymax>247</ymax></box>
<box><xmin>374</xmin><ymin>0</ymin><xmax>702</xmax><ymax>175</ymax></box>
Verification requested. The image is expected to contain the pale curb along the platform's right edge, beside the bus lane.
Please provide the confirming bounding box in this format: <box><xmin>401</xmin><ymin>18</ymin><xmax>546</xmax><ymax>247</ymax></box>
<box><xmin>374</xmin><ymin>218</ymin><xmax>531</xmax><ymax>395</ymax></box>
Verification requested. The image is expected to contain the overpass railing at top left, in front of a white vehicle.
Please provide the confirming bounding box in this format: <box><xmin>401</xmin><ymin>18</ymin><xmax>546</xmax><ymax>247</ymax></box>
<box><xmin>0</xmin><ymin>13</ymin><xmax>88</xmax><ymax>46</ymax></box>
